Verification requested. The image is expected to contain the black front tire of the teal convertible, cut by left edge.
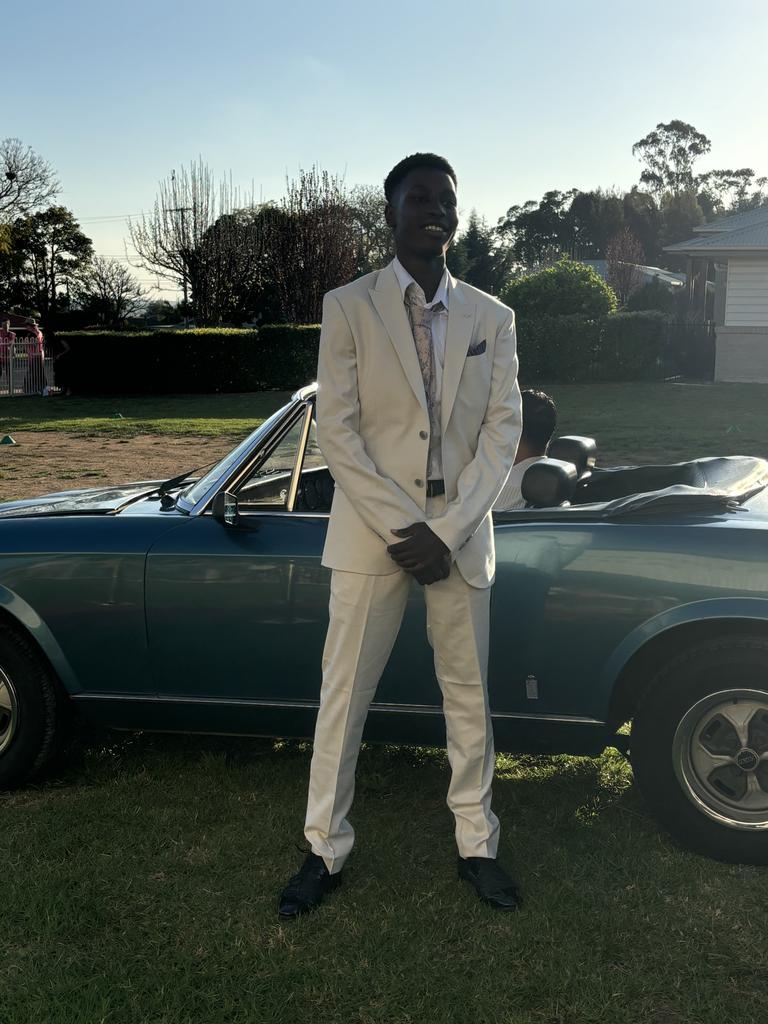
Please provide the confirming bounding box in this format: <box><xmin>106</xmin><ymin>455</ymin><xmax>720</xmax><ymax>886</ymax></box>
<box><xmin>0</xmin><ymin>626</ymin><xmax>63</xmax><ymax>790</ymax></box>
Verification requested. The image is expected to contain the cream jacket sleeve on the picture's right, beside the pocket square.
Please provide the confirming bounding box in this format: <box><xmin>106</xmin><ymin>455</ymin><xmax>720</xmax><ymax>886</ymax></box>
<box><xmin>429</xmin><ymin>309</ymin><xmax>522</xmax><ymax>554</ymax></box>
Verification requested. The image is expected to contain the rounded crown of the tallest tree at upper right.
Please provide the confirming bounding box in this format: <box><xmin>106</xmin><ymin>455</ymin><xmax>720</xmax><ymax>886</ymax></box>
<box><xmin>632</xmin><ymin>121</ymin><xmax>712</xmax><ymax>196</ymax></box>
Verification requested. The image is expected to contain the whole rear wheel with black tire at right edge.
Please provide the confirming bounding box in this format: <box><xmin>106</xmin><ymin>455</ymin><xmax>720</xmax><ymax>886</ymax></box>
<box><xmin>630</xmin><ymin>636</ymin><xmax>768</xmax><ymax>864</ymax></box>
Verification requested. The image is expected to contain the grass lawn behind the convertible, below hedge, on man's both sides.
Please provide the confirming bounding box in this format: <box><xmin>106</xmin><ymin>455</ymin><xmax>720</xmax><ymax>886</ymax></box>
<box><xmin>0</xmin><ymin>384</ymin><xmax>768</xmax><ymax>464</ymax></box>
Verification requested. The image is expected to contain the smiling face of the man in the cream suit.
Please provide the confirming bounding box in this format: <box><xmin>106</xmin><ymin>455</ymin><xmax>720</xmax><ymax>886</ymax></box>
<box><xmin>385</xmin><ymin>167</ymin><xmax>459</xmax><ymax>259</ymax></box>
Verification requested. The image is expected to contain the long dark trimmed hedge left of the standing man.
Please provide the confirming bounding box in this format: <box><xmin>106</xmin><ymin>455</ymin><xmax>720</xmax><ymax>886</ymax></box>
<box><xmin>57</xmin><ymin>324</ymin><xmax>319</xmax><ymax>395</ymax></box>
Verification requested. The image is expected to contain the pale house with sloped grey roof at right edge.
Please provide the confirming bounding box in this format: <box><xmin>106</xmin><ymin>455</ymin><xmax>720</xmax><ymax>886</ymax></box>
<box><xmin>665</xmin><ymin>206</ymin><xmax>768</xmax><ymax>383</ymax></box>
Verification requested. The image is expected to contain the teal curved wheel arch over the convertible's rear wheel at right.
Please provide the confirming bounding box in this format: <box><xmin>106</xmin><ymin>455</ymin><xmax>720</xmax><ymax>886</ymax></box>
<box><xmin>602</xmin><ymin>598</ymin><xmax>768</xmax><ymax>729</ymax></box>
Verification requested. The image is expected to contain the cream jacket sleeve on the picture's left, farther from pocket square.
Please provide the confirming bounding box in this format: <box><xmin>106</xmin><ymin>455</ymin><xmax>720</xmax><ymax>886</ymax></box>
<box><xmin>316</xmin><ymin>294</ymin><xmax>425</xmax><ymax>544</ymax></box>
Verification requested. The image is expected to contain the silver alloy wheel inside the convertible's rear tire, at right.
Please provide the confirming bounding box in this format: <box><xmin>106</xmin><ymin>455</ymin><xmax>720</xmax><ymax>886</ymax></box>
<box><xmin>672</xmin><ymin>689</ymin><xmax>768</xmax><ymax>830</ymax></box>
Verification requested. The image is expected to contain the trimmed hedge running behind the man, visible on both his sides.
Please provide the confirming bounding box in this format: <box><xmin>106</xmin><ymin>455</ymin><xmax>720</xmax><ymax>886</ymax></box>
<box><xmin>58</xmin><ymin>312</ymin><xmax>667</xmax><ymax>395</ymax></box>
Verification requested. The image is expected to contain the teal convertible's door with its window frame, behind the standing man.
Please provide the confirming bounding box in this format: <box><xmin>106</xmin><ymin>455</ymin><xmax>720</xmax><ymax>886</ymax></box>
<box><xmin>146</xmin><ymin>401</ymin><xmax>439</xmax><ymax>707</ymax></box>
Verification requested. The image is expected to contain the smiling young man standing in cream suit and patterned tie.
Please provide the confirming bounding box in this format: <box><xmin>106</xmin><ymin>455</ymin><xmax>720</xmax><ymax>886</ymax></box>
<box><xmin>279</xmin><ymin>154</ymin><xmax>520</xmax><ymax>918</ymax></box>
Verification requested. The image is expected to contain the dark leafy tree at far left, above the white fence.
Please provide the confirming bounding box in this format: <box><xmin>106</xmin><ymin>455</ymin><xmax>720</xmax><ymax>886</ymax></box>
<box><xmin>11</xmin><ymin>206</ymin><xmax>93</xmax><ymax>323</ymax></box>
